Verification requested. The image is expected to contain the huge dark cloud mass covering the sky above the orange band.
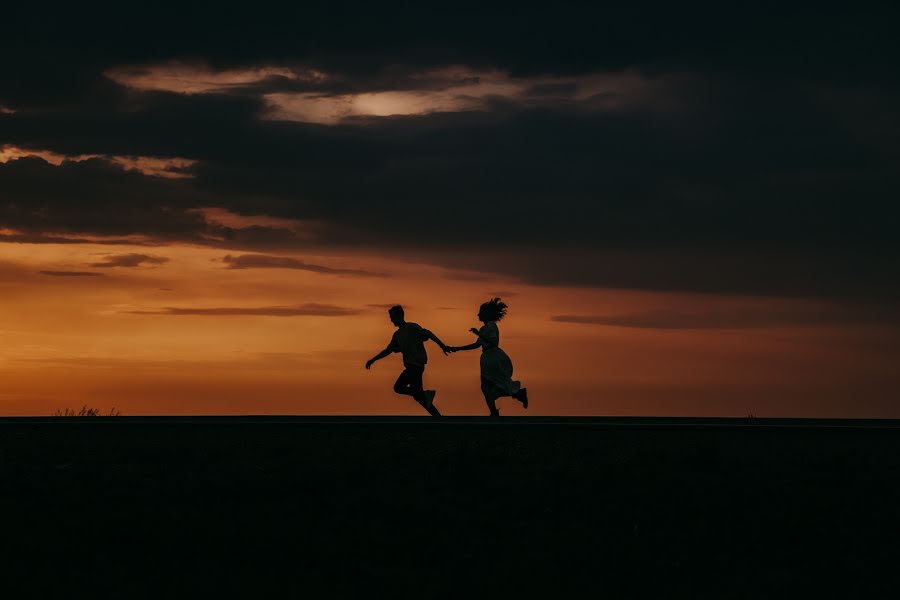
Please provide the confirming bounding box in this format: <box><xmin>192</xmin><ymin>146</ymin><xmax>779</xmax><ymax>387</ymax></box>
<box><xmin>0</xmin><ymin>4</ymin><xmax>900</xmax><ymax>296</ymax></box>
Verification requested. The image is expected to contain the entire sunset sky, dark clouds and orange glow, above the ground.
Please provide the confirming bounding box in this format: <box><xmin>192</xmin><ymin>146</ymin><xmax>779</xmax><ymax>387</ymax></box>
<box><xmin>0</xmin><ymin>3</ymin><xmax>900</xmax><ymax>418</ymax></box>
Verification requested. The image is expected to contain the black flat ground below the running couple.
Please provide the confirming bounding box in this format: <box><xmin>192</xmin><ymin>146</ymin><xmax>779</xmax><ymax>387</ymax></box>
<box><xmin>0</xmin><ymin>417</ymin><xmax>900</xmax><ymax>599</ymax></box>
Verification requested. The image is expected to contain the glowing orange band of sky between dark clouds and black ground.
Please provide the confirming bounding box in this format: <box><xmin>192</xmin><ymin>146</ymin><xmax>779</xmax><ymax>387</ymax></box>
<box><xmin>0</xmin><ymin>236</ymin><xmax>900</xmax><ymax>417</ymax></box>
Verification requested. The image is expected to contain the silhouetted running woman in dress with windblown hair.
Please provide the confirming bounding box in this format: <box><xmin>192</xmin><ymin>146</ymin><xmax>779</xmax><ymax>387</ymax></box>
<box><xmin>447</xmin><ymin>298</ymin><xmax>528</xmax><ymax>417</ymax></box>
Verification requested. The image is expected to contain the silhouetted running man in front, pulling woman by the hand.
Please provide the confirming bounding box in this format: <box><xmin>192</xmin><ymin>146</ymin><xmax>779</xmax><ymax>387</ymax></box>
<box><xmin>366</xmin><ymin>305</ymin><xmax>448</xmax><ymax>417</ymax></box>
